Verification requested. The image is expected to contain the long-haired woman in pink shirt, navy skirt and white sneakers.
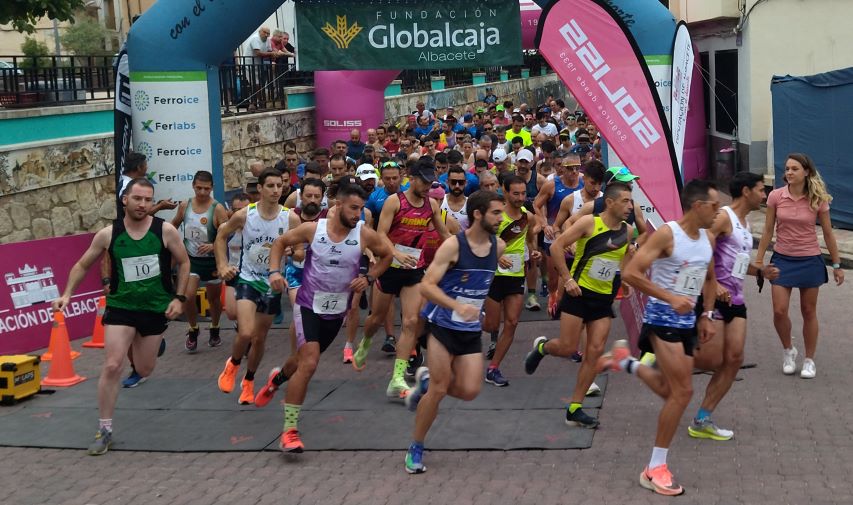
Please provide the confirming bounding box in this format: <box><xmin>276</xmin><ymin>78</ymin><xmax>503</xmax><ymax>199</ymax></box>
<box><xmin>756</xmin><ymin>153</ymin><xmax>844</xmax><ymax>379</ymax></box>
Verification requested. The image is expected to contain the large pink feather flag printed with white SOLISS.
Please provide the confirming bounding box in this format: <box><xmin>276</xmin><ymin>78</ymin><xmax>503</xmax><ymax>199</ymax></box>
<box><xmin>537</xmin><ymin>0</ymin><xmax>681</xmax><ymax>221</ymax></box>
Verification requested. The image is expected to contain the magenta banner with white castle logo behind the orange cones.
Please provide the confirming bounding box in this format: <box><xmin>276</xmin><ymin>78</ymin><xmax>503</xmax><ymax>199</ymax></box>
<box><xmin>0</xmin><ymin>233</ymin><xmax>102</xmax><ymax>354</ymax></box>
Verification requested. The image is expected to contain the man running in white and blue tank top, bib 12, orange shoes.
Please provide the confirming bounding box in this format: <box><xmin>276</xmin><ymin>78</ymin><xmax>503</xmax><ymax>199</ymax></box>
<box><xmin>601</xmin><ymin>180</ymin><xmax>720</xmax><ymax>496</ymax></box>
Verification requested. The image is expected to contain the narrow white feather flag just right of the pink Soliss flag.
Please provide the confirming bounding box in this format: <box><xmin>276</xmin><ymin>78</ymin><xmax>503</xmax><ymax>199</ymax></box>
<box><xmin>670</xmin><ymin>21</ymin><xmax>693</xmax><ymax>175</ymax></box>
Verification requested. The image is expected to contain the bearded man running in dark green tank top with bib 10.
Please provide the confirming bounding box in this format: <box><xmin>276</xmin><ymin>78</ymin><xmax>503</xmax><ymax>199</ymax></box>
<box><xmin>52</xmin><ymin>178</ymin><xmax>190</xmax><ymax>456</ymax></box>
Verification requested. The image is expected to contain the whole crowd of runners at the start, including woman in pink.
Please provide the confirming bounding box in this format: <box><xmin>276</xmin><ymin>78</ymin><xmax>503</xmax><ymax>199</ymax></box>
<box><xmin>54</xmin><ymin>94</ymin><xmax>844</xmax><ymax>495</ymax></box>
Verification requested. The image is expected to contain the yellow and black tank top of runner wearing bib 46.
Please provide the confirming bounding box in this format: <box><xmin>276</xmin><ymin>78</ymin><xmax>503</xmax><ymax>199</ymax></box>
<box><xmin>572</xmin><ymin>215</ymin><xmax>628</xmax><ymax>296</ymax></box>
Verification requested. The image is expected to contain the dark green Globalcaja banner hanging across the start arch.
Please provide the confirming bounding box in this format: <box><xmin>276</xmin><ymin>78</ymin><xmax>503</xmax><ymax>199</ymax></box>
<box><xmin>296</xmin><ymin>0</ymin><xmax>522</xmax><ymax>70</ymax></box>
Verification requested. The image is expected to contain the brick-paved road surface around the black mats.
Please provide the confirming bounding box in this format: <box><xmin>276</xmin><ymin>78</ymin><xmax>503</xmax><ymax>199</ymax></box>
<box><xmin>0</xmin><ymin>276</ymin><xmax>853</xmax><ymax>505</ymax></box>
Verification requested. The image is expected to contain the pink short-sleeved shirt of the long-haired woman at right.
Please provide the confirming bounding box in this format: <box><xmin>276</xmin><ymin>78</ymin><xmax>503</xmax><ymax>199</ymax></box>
<box><xmin>767</xmin><ymin>186</ymin><xmax>829</xmax><ymax>256</ymax></box>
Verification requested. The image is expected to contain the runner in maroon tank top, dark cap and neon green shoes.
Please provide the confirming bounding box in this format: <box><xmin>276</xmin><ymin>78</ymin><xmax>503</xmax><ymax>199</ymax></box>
<box><xmin>353</xmin><ymin>157</ymin><xmax>448</xmax><ymax>398</ymax></box>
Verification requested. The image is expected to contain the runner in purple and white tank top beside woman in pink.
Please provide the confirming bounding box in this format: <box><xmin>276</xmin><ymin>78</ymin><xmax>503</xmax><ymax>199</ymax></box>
<box><xmin>687</xmin><ymin>172</ymin><xmax>779</xmax><ymax>440</ymax></box>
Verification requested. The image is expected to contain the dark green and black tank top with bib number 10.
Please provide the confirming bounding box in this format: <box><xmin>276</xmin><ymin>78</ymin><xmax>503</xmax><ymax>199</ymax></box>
<box><xmin>107</xmin><ymin>217</ymin><xmax>174</xmax><ymax>313</ymax></box>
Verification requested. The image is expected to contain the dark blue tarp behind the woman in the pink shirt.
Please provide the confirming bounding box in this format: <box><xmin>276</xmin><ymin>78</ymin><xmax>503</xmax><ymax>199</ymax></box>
<box><xmin>770</xmin><ymin>67</ymin><xmax>853</xmax><ymax>229</ymax></box>
